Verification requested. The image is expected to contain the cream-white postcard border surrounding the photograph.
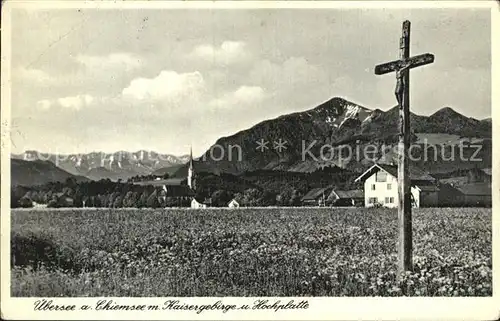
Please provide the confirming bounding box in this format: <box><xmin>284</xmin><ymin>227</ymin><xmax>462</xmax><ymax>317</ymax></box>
<box><xmin>0</xmin><ymin>0</ymin><xmax>500</xmax><ymax>320</ymax></box>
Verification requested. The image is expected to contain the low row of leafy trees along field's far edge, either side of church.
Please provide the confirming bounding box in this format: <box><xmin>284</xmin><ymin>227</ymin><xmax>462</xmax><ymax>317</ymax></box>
<box><xmin>11</xmin><ymin>181</ymin><xmax>302</xmax><ymax>208</ymax></box>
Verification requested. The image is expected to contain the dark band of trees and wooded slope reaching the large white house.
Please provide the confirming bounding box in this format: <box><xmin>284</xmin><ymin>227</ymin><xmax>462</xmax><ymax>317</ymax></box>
<box><xmin>11</xmin><ymin>168</ymin><xmax>353</xmax><ymax>208</ymax></box>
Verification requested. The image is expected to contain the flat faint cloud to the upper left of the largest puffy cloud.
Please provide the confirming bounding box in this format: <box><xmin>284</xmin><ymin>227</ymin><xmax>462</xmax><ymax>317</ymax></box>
<box><xmin>75</xmin><ymin>52</ymin><xmax>142</xmax><ymax>71</ymax></box>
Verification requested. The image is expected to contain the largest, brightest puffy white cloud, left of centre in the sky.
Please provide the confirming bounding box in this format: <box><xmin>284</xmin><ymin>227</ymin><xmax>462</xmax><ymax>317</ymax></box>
<box><xmin>122</xmin><ymin>70</ymin><xmax>205</xmax><ymax>103</ymax></box>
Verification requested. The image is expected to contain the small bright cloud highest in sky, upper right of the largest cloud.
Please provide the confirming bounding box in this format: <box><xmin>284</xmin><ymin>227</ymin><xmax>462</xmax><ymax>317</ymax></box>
<box><xmin>191</xmin><ymin>41</ymin><xmax>249</xmax><ymax>65</ymax></box>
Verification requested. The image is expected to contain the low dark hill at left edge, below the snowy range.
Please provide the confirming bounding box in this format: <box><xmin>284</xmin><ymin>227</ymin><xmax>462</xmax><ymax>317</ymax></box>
<box><xmin>11</xmin><ymin>159</ymin><xmax>89</xmax><ymax>186</ymax></box>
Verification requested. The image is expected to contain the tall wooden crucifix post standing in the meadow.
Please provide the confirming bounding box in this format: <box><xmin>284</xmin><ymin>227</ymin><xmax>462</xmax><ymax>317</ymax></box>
<box><xmin>375</xmin><ymin>20</ymin><xmax>434</xmax><ymax>274</ymax></box>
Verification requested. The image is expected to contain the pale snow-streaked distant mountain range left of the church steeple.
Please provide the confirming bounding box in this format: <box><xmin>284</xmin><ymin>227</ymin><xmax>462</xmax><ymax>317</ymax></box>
<box><xmin>12</xmin><ymin>150</ymin><xmax>189</xmax><ymax>181</ymax></box>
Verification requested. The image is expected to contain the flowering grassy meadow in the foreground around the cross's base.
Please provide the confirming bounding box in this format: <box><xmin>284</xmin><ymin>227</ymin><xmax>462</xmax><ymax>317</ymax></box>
<box><xmin>11</xmin><ymin>208</ymin><xmax>492</xmax><ymax>296</ymax></box>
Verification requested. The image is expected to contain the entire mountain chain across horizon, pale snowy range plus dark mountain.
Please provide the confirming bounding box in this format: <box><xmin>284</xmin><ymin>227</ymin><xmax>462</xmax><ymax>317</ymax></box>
<box><xmin>12</xmin><ymin>97</ymin><xmax>492</xmax><ymax>182</ymax></box>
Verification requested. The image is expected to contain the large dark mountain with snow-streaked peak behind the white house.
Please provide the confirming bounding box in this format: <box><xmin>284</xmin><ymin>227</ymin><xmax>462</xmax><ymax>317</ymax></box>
<box><xmin>175</xmin><ymin>97</ymin><xmax>492</xmax><ymax>176</ymax></box>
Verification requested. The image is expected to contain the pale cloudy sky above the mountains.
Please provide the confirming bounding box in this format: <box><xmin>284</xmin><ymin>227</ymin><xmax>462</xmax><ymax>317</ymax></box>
<box><xmin>11</xmin><ymin>9</ymin><xmax>491</xmax><ymax>156</ymax></box>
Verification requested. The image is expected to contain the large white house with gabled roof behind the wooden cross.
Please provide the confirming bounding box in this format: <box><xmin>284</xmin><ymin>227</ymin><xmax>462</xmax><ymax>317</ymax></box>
<box><xmin>355</xmin><ymin>164</ymin><xmax>439</xmax><ymax>207</ymax></box>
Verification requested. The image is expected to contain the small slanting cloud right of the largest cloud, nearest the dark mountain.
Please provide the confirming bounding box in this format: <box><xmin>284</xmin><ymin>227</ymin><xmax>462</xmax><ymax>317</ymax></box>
<box><xmin>209</xmin><ymin>86</ymin><xmax>266</xmax><ymax>108</ymax></box>
